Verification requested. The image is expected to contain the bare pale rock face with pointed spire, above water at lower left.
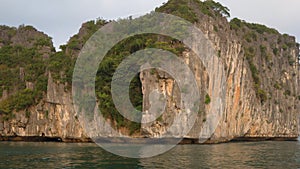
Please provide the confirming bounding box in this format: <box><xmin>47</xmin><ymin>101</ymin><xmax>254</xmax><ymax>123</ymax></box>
<box><xmin>0</xmin><ymin>73</ymin><xmax>87</xmax><ymax>141</ymax></box>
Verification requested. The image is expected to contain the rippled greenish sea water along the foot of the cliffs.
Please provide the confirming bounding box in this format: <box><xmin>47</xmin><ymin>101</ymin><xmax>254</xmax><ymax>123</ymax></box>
<box><xmin>0</xmin><ymin>142</ymin><xmax>300</xmax><ymax>169</ymax></box>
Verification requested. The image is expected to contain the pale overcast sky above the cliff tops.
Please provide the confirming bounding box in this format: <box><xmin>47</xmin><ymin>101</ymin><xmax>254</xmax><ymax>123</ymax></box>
<box><xmin>0</xmin><ymin>0</ymin><xmax>300</xmax><ymax>47</ymax></box>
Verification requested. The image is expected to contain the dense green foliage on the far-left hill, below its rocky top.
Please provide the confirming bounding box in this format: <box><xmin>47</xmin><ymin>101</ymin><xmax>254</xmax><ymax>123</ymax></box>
<box><xmin>0</xmin><ymin>35</ymin><xmax>52</xmax><ymax>117</ymax></box>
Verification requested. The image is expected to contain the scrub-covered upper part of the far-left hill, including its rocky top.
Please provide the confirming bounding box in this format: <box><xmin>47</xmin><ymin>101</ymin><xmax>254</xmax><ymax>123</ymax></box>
<box><xmin>0</xmin><ymin>25</ymin><xmax>54</xmax><ymax>119</ymax></box>
